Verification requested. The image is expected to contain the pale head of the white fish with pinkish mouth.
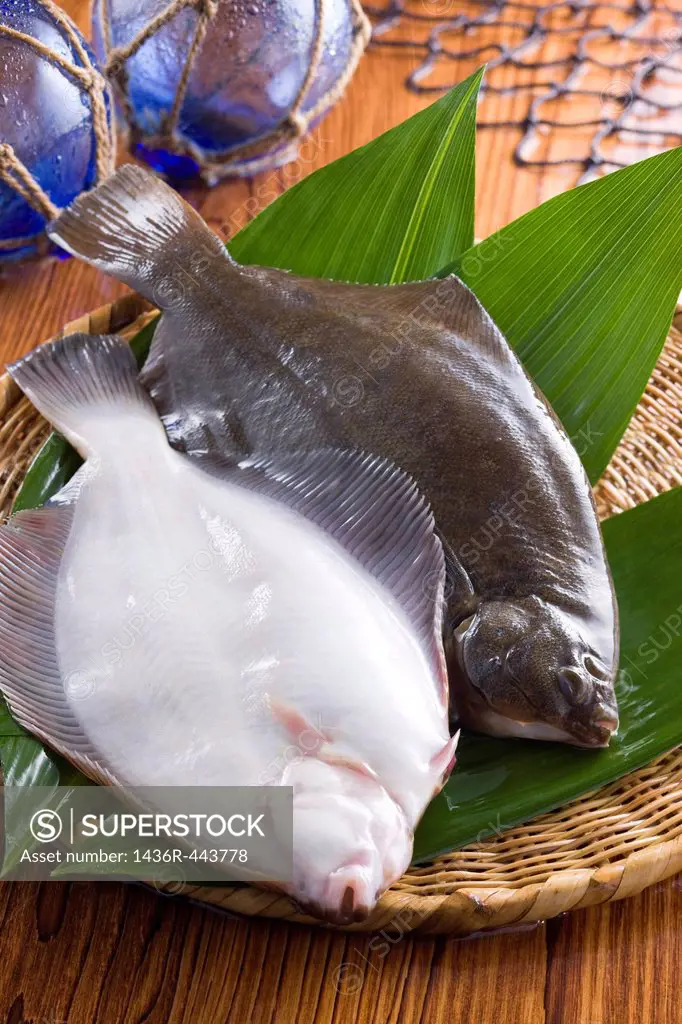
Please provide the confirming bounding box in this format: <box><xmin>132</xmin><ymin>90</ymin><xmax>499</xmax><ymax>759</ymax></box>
<box><xmin>283</xmin><ymin>758</ymin><xmax>413</xmax><ymax>925</ymax></box>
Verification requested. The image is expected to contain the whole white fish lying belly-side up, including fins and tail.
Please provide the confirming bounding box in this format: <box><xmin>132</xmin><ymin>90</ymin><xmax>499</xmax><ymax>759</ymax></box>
<box><xmin>0</xmin><ymin>336</ymin><xmax>457</xmax><ymax>922</ymax></box>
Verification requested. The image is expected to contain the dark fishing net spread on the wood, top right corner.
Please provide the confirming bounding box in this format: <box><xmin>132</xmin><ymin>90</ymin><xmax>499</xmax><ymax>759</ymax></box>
<box><xmin>366</xmin><ymin>0</ymin><xmax>682</xmax><ymax>180</ymax></box>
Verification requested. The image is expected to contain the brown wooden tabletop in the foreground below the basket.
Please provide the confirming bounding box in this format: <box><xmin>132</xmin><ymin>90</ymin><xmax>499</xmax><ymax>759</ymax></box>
<box><xmin>0</xmin><ymin>881</ymin><xmax>682</xmax><ymax>1024</ymax></box>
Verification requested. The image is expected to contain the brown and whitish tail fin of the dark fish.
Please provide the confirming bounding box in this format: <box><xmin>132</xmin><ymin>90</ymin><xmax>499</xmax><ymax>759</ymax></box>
<box><xmin>47</xmin><ymin>164</ymin><xmax>233</xmax><ymax>309</ymax></box>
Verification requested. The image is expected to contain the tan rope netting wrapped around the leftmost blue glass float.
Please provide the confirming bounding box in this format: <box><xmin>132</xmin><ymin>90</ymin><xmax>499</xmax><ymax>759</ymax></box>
<box><xmin>0</xmin><ymin>0</ymin><xmax>115</xmax><ymax>253</ymax></box>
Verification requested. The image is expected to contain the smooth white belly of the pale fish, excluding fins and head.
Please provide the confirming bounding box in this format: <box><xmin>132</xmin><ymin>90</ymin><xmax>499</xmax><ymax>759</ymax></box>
<box><xmin>62</xmin><ymin>414</ymin><xmax>449</xmax><ymax>824</ymax></box>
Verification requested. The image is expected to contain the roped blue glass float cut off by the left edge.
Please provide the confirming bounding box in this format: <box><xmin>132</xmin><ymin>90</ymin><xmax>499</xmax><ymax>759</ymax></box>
<box><xmin>0</xmin><ymin>0</ymin><xmax>114</xmax><ymax>262</ymax></box>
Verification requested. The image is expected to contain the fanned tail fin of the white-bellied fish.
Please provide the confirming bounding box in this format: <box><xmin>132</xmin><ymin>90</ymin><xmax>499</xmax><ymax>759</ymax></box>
<box><xmin>7</xmin><ymin>334</ymin><xmax>162</xmax><ymax>457</ymax></box>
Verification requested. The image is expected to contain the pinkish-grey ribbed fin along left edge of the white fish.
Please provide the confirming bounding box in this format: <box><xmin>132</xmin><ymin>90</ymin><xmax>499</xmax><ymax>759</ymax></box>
<box><xmin>0</xmin><ymin>506</ymin><xmax>113</xmax><ymax>783</ymax></box>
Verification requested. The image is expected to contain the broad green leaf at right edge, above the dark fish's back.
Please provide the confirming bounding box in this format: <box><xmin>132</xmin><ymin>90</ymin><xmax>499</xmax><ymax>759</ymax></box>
<box><xmin>451</xmin><ymin>146</ymin><xmax>682</xmax><ymax>481</ymax></box>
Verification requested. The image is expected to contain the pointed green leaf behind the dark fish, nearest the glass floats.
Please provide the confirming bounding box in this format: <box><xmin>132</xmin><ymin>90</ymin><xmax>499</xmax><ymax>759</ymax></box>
<box><xmin>229</xmin><ymin>69</ymin><xmax>483</xmax><ymax>284</ymax></box>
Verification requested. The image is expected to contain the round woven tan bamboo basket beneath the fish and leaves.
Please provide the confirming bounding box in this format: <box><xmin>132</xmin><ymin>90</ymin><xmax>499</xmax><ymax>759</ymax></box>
<box><xmin>0</xmin><ymin>296</ymin><xmax>682</xmax><ymax>935</ymax></box>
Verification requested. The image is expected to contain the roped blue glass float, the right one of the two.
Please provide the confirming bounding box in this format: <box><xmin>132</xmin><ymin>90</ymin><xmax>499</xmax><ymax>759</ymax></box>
<box><xmin>93</xmin><ymin>0</ymin><xmax>369</xmax><ymax>183</ymax></box>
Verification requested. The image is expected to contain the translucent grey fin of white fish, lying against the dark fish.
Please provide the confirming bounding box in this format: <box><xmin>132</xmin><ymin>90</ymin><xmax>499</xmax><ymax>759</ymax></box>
<box><xmin>202</xmin><ymin>450</ymin><xmax>445</xmax><ymax>677</ymax></box>
